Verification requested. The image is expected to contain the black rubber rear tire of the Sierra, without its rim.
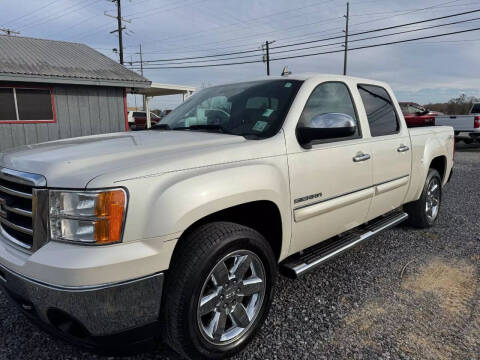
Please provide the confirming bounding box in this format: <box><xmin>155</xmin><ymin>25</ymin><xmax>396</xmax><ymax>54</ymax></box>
<box><xmin>404</xmin><ymin>169</ymin><xmax>442</xmax><ymax>229</ymax></box>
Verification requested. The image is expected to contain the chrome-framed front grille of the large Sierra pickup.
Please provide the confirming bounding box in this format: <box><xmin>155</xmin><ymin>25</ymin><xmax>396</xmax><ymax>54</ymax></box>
<box><xmin>0</xmin><ymin>168</ymin><xmax>46</xmax><ymax>250</ymax></box>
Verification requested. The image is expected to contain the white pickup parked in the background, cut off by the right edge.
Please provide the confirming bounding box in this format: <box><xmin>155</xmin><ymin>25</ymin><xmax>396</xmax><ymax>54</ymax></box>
<box><xmin>435</xmin><ymin>103</ymin><xmax>480</xmax><ymax>144</ymax></box>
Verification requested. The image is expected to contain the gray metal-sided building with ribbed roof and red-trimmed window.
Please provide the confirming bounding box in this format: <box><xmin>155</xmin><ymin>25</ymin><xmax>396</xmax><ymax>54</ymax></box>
<box><xmin>0</xmin><ymin>36</ymin><xmax>151</xmax><ymax>151</ymax></box>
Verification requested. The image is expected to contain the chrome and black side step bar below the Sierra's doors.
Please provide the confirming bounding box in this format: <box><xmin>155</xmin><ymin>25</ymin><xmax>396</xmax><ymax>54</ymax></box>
<box><xmin>280</xmin><ymin>211</ymin><xmax>408</xmax><ymax>279</ymax></box>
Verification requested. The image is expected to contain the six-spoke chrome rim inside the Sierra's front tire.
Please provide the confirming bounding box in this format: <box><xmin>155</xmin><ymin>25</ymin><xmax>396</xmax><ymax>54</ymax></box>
<box><xmin>197</xmin><ymin>250</ymin><xmax>266</xmax><ymax>345</ymax></box>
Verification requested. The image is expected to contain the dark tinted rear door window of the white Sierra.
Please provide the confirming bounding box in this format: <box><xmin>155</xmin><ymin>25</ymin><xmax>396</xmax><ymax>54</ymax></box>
<box><xmin>358</xmin><ymin>85</ymin><xmax>400</xmax><ymax>136</ymax></box>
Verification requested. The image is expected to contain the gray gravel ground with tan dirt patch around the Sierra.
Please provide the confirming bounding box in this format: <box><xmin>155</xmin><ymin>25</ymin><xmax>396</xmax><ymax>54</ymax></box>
<box><xmin>0</xmin><ymin>145</ymin><xmax>480</xmax><ymax>360</ymax></box>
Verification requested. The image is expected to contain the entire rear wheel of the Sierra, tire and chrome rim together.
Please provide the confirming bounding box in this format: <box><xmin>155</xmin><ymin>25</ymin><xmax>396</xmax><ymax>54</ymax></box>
<box><xmin>405</xmin><ymin>169</ymin><xmax>442</xmax><ymax>229</ymax></box>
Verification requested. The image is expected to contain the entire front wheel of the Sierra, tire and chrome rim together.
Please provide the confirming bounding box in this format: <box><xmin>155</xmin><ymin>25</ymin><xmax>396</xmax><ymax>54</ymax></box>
<box><xmin>162</xmin><ymin>222</ymin><xmax>276</xmax><ymax>359</ymax></box>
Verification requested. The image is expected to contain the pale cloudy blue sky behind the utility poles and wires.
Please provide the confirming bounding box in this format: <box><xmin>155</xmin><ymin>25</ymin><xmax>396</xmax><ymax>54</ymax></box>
<box><xmin>0</xmin><ymin>0</ymin><xmax>480</xmax><ymax>109</ymax></box>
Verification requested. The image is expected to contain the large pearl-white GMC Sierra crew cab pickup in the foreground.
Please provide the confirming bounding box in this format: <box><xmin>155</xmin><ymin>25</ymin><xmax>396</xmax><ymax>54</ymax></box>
<box><xmin>0</xmin><ymin>75</ymin><xmax>454</xmax><ymax>359</ymax></box>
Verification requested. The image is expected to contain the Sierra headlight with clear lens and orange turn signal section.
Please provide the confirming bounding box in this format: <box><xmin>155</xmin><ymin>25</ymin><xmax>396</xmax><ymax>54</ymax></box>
<box><xmin>50</xmin><ymin>189</ymin><xmax>127</xmax><ymax>245</ymax></box>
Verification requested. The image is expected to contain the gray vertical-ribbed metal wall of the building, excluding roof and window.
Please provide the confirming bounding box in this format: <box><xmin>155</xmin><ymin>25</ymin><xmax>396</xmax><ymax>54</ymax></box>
<box><xmin>0</xmin><ymin>85</ymin><xmax>125</xmax><ymax>151</ymax></box>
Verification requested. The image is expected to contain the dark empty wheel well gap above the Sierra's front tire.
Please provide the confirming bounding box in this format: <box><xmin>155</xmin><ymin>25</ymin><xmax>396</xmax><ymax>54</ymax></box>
<box><xmin>176</xmin><ymin>200</ymin><xmax>282</xmax><ymax>260</ymax></box>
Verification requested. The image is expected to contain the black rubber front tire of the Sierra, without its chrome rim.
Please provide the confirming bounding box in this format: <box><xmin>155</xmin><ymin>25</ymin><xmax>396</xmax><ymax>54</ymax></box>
<box><xmin>161</xmin><ymin>222</ymin><xmax>277</xmax><ymax>359</ymax></box>
